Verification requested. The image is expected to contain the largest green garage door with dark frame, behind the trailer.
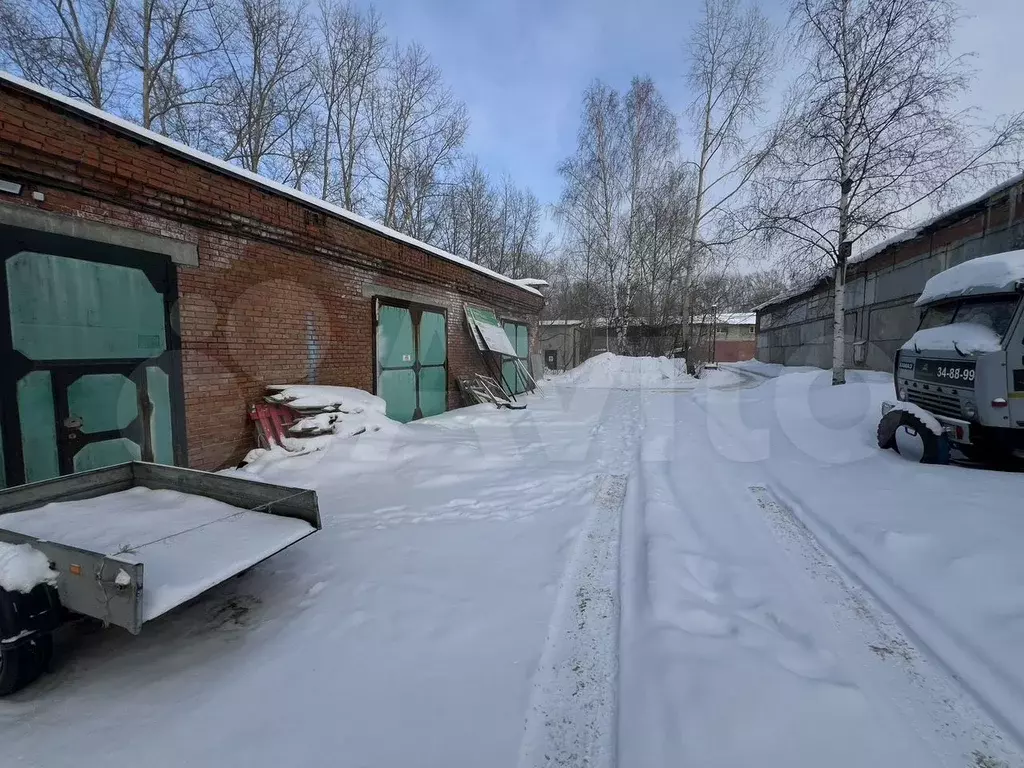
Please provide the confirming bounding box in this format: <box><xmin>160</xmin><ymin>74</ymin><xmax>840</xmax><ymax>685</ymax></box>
<box><xmin>0</xmin><ymin>227</ymin><xmax>181</xmax><ymax>484</ymax></box>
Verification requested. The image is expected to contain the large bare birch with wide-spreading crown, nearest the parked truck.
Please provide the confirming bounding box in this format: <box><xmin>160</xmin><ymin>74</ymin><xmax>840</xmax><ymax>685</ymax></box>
<box><xmin>756</xmin><ymin>0</ymin><xmax>1024</xmax><ymax>384</ymax></box>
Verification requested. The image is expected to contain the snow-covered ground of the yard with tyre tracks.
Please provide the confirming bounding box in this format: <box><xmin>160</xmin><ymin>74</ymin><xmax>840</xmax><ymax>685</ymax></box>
<box><xmin>0</xmin><ymin>355</ymin><xmax>1024</xmax><ymax>768</ymax></box>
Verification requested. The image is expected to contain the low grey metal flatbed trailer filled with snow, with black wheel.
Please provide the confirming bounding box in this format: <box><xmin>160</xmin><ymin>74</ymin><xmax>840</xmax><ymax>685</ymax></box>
<box><xmin>0</xmin><ymin>462</ymin><xmax>322</xmax><ymax>695</ymax></box>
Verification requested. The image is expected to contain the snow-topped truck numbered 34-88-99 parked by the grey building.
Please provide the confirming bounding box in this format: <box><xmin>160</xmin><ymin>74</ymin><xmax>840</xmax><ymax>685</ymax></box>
<box><xmin>878</xmin><ymin>250</ymin><xmax>1024</xmax><ymax>463</ymax></box>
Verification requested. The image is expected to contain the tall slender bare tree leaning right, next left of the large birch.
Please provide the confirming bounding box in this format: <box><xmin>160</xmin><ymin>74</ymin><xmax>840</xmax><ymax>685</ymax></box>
<box><xmin>682</xmin><ymin>0</ymin><xmax>774</xmax><ymax>358</ymax></box>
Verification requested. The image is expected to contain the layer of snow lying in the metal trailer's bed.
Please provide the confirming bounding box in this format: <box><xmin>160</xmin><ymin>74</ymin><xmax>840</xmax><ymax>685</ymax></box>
<box><xmin>0</xmin><ymin>487</ymin><xmax>313</xmax><ymax>622</ymax></box>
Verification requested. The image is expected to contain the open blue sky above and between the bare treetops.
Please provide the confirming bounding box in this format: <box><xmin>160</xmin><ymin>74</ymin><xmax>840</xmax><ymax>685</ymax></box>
<box><xmin>358</xmin><ymin>0</ymin><xmax>1024</xmax><ymax>215</ymax></box>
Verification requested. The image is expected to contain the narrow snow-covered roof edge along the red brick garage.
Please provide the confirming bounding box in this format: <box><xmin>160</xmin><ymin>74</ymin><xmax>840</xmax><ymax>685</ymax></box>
<box><xmin>0</xmin><ymin>71</ymin><xmax>542</xmax><ymax>296</ymax></box>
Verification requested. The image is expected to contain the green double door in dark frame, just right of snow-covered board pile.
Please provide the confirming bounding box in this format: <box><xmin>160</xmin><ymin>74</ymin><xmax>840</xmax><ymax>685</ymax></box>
<box><xmin>377</xmin><ymin>300</ymin><xmax>447</xmax><ymax>422</ymax></box>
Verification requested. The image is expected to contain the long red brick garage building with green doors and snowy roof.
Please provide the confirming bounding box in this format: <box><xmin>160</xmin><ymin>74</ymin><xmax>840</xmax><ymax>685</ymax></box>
<box><xmin>0</xmin><ymin>75</ymin><xmax>544</xmax><ymax>485</ymax></box>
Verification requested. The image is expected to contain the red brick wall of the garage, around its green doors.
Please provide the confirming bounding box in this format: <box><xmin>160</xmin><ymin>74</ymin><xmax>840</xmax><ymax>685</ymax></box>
<box><xmin>0</xmin><ymin>82</ymin><xmax>543</xmax><ymax>469</ymax></box>
